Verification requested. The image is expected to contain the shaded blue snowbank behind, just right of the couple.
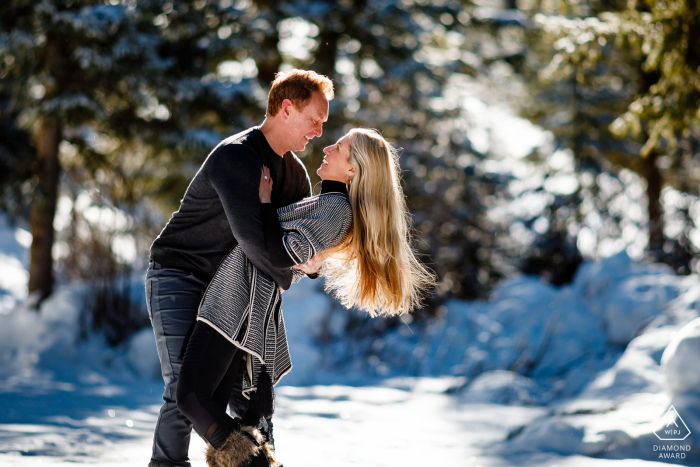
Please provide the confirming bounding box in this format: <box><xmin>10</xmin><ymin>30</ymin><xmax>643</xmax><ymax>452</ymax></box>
<box><xmin>324</xmin><ymin>252</ymin><xmax>686</xmax><ymax>401</ymax></box>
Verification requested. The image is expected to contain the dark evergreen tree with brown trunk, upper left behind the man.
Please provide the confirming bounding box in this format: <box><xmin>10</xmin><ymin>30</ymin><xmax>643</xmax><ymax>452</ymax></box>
<box><xmin>0</xmin><ymin>0</ymin><xmax>260</xmax><ymax>299</ymax></box>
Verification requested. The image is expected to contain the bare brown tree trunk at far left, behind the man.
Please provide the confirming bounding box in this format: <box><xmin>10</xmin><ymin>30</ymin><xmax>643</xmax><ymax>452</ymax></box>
<box><xmin>29</xmin><ymin>117</ymin><xmax>61</xmax><ymax>306</ymax></box>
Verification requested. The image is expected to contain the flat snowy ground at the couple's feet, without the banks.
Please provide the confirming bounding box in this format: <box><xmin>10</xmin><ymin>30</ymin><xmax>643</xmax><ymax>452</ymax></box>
<box><xmin>0</xmin><ymin>378</ymin><xmax>661</xmax><ymax>467</ymax></box>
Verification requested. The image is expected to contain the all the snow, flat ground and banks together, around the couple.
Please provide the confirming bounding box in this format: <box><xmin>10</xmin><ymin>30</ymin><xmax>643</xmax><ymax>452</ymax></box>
<box><xmin>0</xmin><ymin>213</ymin><xmax>700</xmax><ymax>467</ymax></box>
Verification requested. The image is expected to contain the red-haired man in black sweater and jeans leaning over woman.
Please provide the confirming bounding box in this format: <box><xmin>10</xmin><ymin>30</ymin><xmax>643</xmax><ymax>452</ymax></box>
<box><xmin>146</xmin><ymin>70</ymin><xmax>333</xmax><ymax>467</ymax></box>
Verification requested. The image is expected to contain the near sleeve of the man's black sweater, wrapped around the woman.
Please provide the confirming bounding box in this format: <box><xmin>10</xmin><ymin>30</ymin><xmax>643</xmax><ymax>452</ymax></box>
<box><xmin>208</xmin><ymin>144</ymin><xmax>292</xmax><ymax>290</ymax></box>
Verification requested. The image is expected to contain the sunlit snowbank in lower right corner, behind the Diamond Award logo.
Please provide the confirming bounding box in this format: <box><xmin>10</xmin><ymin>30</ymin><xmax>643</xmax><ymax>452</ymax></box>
<box><xmin>502</xmin><ymin>274</ymin><xmax>700</xmax><ymax>465</ymax></box>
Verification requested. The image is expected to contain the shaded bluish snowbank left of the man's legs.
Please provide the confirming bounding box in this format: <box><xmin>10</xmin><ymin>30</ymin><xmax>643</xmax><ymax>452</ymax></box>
<box><xmin>0</xmin><ymin>283</ymin><xmax>161</xmax><ymax>390</ymax></box>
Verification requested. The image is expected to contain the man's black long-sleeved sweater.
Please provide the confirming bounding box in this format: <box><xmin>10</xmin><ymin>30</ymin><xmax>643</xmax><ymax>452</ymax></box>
<box><xmin>151</xmin><ymin>127</ymin><xmax>311</xmax><ymax>289</ymax></box>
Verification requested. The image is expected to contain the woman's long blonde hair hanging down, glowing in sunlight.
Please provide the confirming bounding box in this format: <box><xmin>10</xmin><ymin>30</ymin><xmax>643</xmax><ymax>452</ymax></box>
<box><xmin>324</xmin><ymin>128</ymin><xmax>435</xmax><ymax>316</ymax></box>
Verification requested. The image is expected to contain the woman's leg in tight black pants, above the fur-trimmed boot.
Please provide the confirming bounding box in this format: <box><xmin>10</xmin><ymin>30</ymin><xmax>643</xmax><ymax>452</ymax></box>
<box><xmin>177</xmin><ymin>321</ymin><xmax>243</xmax><ymax>449</ymax></box>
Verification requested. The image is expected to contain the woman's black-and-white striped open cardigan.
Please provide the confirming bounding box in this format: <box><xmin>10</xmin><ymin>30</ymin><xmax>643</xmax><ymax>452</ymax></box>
<box><xmin>197</xmin><ymin>185</ymin><xmax>352</xmax><ymax>397</ymax></box>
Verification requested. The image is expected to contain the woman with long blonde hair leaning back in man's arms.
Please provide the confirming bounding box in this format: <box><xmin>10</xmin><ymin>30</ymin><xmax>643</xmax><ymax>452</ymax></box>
<box><xmin>177</xmin><ymin>129</ymin><xmax>433</xmax><ymax>466</ymax></box>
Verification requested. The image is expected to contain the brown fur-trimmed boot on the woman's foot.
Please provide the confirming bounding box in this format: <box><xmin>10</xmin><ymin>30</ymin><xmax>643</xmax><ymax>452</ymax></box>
<box><xmin>206</xmin><ymin>426</ymin><xmax>281</xmax><ymax>467</ymax></box>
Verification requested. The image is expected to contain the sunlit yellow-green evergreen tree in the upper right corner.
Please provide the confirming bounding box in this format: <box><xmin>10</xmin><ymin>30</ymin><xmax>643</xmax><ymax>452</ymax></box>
<box><xmin>524</xmin><ymin>0</ymin><xmax>700</xmax><ymax>264</ymax></box>
